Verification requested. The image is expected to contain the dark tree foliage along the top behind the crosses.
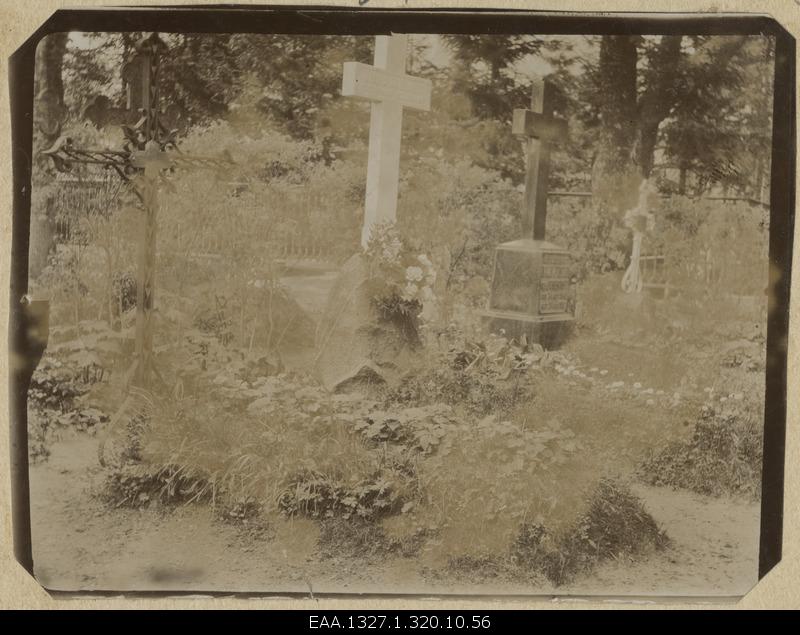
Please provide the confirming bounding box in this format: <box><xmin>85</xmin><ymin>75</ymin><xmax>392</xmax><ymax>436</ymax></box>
<box><xmin>48</xmin><ymin>33</ymin><xmax>773</xmax><ymax>201</ymax></box>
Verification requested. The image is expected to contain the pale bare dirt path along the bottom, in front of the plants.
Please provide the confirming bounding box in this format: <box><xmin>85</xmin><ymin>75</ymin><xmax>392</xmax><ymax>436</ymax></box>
<box><xmin>31</xmin><ymin>436</ymin><xmax>759</xmax><ymax>596</ymax></box>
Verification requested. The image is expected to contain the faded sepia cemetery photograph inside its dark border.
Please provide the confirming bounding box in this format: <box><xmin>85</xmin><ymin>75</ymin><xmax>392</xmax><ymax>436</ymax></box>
<box><xmin>9</xmin><ymin>7</ymin><xmax>793</xmax><ymax>599</ymax></box>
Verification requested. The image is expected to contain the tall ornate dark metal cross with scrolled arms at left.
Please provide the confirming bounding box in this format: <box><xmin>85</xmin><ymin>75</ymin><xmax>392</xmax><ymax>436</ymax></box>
<box><xmin>42</xmin><ymin>33</ymin><xmax>234</xmax><ymax>388</ymax></box>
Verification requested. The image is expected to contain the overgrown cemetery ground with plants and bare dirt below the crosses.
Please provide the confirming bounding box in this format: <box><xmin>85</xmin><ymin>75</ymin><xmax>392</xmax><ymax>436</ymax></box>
<box><xmin>23</xmin><ymin>262</ymin><xmax>763</xmax><ymax>596</ymax></box>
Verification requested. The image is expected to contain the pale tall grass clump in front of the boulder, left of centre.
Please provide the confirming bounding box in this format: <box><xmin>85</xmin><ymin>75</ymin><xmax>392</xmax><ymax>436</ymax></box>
<box><xmin>137</xmin><ymin>378</ymin><xmax>380</xmax><ymax>511</ymax></box>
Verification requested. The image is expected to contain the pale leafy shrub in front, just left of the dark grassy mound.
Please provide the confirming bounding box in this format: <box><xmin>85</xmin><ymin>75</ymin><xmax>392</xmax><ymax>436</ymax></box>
<box><xmin>416</xmin><ymin>416</ymin><xmax>580</xmax><ymax>555</ymax></box>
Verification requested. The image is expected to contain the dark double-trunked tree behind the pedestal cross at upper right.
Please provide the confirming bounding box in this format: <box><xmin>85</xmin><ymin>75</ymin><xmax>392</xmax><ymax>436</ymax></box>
<box><xmin>578</xmin><ymin>36</ymin><xmax>771</xmax><ymax>208</ymax></box>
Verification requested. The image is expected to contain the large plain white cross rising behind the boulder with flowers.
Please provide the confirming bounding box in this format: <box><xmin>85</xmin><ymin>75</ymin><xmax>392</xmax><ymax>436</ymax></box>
<box><xmin>342</xmin><ymin>35</ymin><xmax>431</xmax><ymax>247</ymax></box>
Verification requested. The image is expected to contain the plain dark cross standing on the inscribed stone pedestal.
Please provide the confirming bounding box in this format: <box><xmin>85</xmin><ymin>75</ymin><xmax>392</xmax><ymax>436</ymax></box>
<box><xmin>511</xmin><ymin>80</ymin><xmax>567</xmax><ymax>240</ymax></box>
